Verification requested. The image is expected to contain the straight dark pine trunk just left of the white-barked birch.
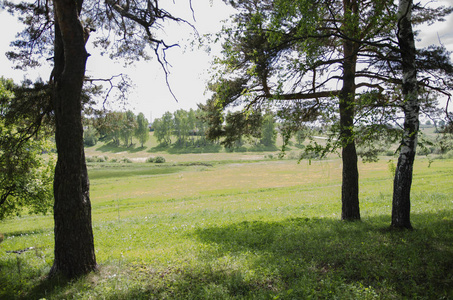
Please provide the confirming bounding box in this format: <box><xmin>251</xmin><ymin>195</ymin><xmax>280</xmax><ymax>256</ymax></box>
<box><xmin>340</xmin><ymin>0</ymin><xmax>360</xmax><ymax>221</ymax></box>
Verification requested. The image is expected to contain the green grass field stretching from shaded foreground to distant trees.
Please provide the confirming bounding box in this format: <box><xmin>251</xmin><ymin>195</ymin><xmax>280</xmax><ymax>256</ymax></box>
<box><xmin>0</xmin><ymin>151</ymin><xmax>453</xmax><ymax>299</ymax></box>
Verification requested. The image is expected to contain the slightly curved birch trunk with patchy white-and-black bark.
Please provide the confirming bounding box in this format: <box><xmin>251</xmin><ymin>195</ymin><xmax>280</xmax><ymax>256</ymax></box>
<box><xmin>391</xmin><ymin>0</ymin><xmax>420</xmax><ymax>229</ymax></box>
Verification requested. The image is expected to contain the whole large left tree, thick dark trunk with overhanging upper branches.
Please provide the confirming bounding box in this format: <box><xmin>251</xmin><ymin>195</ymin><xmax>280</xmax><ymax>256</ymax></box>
<box><xmin>4</xmin><ymin>0</ymin><xmax>194</xmax><ymax>278</ymax></box>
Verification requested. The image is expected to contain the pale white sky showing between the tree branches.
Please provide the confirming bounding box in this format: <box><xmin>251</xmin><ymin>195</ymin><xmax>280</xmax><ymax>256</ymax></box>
<box><xmin>0</xmin><ymin>0</ymin><xmax>453</xmax><ymax>121</ymax></box>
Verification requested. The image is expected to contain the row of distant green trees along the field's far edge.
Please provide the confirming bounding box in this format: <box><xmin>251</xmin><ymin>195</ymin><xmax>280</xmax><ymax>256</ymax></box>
<box><xmin>84</xmin><ymin>105</ymin><xmax>305</xmax><ymax>149</ymax></box>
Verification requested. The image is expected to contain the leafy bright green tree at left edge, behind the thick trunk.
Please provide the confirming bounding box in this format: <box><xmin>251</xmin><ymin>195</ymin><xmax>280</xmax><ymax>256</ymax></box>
<box><xmin>0</xmin><ymin>77</ymin><xmax>55</xmax><ymax>220</ymax></box>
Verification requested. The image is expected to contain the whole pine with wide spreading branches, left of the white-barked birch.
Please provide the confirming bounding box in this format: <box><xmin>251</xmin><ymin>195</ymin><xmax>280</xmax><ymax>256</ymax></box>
<box><xmin>208</xmin><ymin>0</ymin><xmax>391</xmax><ymax>220</ymax></box>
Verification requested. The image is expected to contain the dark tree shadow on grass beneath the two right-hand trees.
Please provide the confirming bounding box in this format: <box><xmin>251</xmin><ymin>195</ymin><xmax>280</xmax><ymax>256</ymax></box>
<box><xmin>185</xmin><ymin>213</ymin><xmax>453</xmax><ymax>298</ymax></box>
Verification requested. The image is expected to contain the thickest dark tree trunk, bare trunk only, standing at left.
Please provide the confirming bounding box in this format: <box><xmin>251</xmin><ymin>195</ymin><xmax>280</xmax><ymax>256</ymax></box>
<box><xmin>50</xmin><ymin>0</ymin><xmax>96</xmax><ymax>278</ymax></box>
